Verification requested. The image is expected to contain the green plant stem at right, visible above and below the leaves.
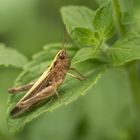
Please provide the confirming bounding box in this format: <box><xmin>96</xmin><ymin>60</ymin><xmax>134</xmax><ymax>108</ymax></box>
<box><xmin>112</xmin><ymin>0</ymin><xmax>140</xmax><ymax>139</ymax></box>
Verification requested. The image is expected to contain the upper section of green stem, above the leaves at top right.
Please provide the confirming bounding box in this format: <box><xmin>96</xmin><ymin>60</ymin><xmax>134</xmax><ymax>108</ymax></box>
<box><xmin>112</xmin><ymin>0</ymin><xmax>126</xmax><ymax>36</ymax></box>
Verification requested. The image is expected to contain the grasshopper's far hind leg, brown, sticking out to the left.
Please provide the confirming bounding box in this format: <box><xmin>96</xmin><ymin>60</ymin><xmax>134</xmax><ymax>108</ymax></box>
<box><xmin>8</xmin><ymin>81</ymin><xmax>35</xmax><ymax>94</ymax></box>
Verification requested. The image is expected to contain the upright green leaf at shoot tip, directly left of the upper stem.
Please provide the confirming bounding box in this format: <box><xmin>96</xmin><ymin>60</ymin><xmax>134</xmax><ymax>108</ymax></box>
<box><xmin>93</xmin><ymin>2</ymin><xmax>114</xmax><ymax>39</ymax></box>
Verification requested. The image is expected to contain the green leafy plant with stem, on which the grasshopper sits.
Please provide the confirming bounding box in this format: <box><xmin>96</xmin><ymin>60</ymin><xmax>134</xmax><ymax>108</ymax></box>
<box><xmin>8</xmin><ymin>0</ymin><xmax>140</xmax><ymax>138</ymax></box>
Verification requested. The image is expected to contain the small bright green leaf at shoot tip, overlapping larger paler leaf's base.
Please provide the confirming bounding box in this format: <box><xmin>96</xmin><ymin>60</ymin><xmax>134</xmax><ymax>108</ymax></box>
<box><xmin>71</xmin><ymin>28</ymin><xmax>99</xmax><ymax>47</ymax></box>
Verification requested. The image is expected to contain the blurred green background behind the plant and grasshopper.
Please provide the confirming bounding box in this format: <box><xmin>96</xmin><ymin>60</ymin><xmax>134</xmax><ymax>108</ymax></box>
<box><xmin>0</xmin><ymin>0</ymin><xmax>140</xmax><ymax>140</ymax></box>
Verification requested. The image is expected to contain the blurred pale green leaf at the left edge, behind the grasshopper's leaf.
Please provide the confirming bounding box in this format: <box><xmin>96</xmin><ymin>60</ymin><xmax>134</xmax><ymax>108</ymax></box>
<box><xmin>0</xmin><ymin>44</ymin><xmax>27</xmax><ymax>68</ymax></box>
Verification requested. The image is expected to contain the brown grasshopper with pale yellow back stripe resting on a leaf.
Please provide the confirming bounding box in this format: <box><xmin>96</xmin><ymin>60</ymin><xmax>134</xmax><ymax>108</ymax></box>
<box><xmin>8</xmin><ymin>49</ymin><xmax>85</xmax><ymax>117</ymax></box>
